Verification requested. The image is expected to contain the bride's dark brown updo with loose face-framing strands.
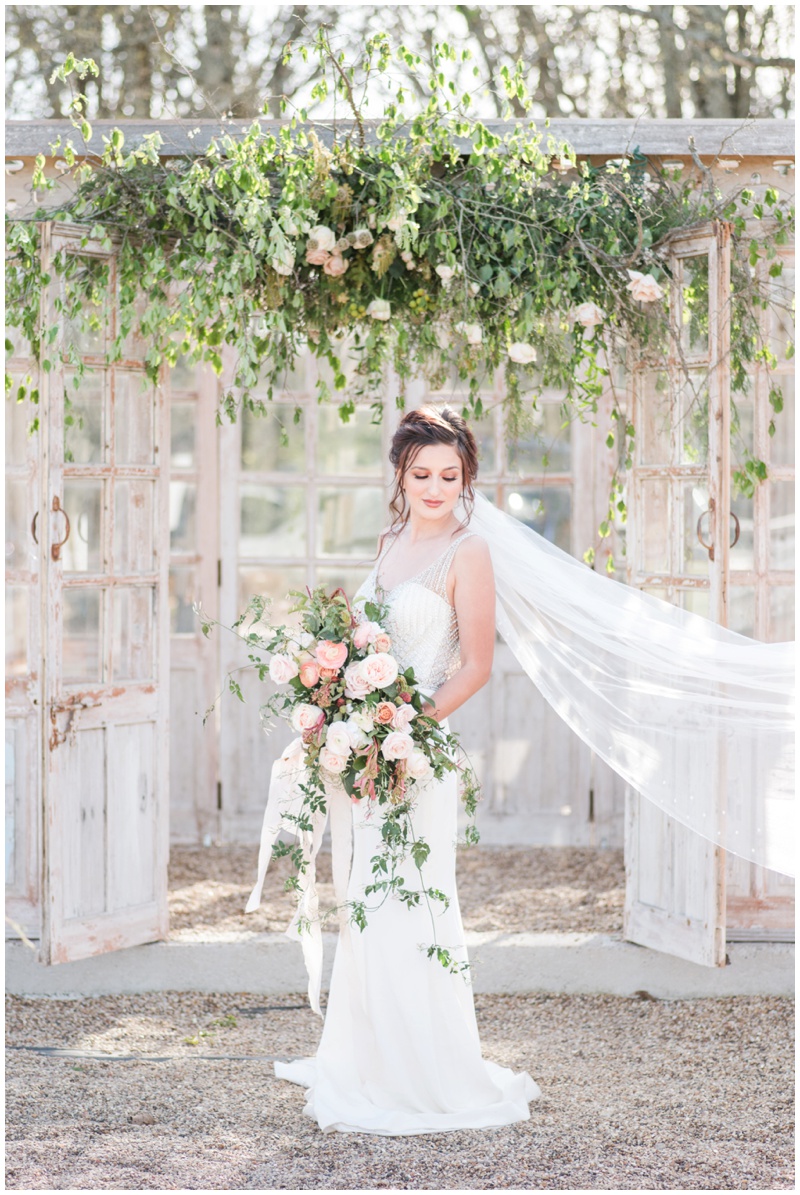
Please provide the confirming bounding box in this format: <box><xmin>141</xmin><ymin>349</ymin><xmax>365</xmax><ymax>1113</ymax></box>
<box><xmin>389</xmin><ymin>406</ymin><xmax>478</xmax><ymax>532</ymax></box>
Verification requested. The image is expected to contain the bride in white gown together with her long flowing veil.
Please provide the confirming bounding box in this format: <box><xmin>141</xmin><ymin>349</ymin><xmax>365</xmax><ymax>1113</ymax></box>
<box><xmin>246</xmin><ymin>407</ymin><xmax>794</xmax><ymax>1135</ymax></box>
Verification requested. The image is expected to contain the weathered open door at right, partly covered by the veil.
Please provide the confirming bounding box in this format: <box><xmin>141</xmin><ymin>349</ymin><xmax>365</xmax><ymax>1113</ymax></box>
<box><xmin>623</xmin><ymin>225</ymin><xmax>737</xmax><ymax>966</ymax></box>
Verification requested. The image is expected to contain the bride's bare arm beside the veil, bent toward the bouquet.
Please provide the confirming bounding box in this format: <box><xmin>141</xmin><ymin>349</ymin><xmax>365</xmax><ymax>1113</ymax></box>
<box><xmin>425</xmin><ymin>535</ymin><xmax>495</xmax><ymax>722</ymax></box>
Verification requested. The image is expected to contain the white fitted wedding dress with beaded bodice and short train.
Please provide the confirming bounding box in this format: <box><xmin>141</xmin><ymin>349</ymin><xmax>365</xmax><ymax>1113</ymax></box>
<box><xmin>265</xmin><ymin>531</ymin><xmax>542</xmax><ymax>1136</ymax></box>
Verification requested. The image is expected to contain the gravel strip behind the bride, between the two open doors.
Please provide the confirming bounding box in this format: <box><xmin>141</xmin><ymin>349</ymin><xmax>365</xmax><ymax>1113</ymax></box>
<box><xmin>170</xmin><ymin>846</ymin><xmax>625</xmax><ymax>939</ymax></box>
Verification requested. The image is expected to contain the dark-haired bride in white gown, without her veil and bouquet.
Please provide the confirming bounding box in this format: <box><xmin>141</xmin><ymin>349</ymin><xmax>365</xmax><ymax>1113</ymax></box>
<box><xmin>248</xmin><ymin>407</ymin><xmax>541</xmax><ymax>1136</ymax></box>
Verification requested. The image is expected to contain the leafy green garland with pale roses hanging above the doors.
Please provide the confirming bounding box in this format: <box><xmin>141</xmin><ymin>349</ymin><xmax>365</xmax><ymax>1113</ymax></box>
<box><xmin>6</xmin><ymin>30</ymin><xmax>794</xmax><ymax>554</ymax></box>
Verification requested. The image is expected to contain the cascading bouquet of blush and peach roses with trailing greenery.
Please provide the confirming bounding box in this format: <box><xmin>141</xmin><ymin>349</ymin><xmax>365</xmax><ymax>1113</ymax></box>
<box><xmin>203</xmin><ymin>587</ymin><xmax>480</xmax><ymax>972</ymax></box>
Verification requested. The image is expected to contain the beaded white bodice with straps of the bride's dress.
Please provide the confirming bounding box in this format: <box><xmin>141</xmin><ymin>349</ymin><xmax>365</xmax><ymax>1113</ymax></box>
<box><xmin>353</xmin><ymin>531</ymin><xmax>477</xmax><ymax>693</ymax></box>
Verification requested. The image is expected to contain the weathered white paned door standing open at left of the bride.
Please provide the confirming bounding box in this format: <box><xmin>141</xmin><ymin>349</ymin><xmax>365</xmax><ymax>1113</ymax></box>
<box><xmin>37</xmin><ymin>225</ymin><xmax>169</xmax><ymax>963</ymax></box>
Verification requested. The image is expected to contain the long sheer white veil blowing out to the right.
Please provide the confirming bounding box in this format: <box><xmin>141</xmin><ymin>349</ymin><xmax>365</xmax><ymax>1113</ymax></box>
<box><xmin>460</xmin><ymin>494</ymin><xmax>795</xmax><ymax>876</ymax></box>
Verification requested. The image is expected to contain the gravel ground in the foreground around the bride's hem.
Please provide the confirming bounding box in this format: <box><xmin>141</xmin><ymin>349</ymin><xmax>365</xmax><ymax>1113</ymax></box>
<box><xmin>6</xmin><ymin>993</ymin><xmax>794</xmax><ymax>1190</ymax></box>
